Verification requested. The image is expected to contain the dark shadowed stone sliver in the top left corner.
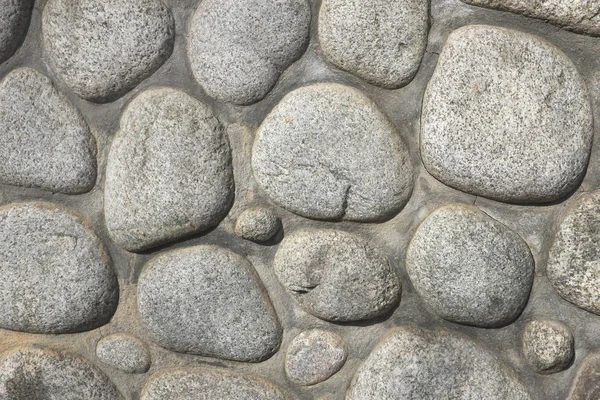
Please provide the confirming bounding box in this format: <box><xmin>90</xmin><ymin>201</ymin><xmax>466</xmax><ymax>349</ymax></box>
<box><xmin>0</xmin><ymin>0</ymin><xmax>34</xmax><ymax>63</ymax></box>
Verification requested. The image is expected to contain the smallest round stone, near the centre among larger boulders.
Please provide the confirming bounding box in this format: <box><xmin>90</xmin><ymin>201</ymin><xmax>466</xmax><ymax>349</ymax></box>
<box><xmin>235</xmin><ymin>208</ymin><xmax>281</xmax><ymax>242</ymax></box>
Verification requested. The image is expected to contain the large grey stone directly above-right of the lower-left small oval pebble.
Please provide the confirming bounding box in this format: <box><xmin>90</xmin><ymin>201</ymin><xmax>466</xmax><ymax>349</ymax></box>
<box><xmin>138</xmin><ymin>246</ymin><xmax>282</xmax><ymax>361</ymax></box>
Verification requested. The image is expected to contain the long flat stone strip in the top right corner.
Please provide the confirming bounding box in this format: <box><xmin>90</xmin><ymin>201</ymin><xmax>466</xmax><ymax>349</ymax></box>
<box><xmin>462</xmin><ymin>0</ymin><xmax>600</xmax><ymax>36</ymax></box>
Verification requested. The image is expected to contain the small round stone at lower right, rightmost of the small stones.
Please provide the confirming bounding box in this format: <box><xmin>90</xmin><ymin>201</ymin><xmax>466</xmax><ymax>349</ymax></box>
<box><xmin>523</xmin><ymin>320</ymin><xmax>575</xmax><ymax>374</ymax></box>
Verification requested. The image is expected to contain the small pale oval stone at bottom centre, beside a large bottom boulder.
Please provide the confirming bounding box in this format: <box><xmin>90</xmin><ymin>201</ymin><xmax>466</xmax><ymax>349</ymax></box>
<box><xmin>285</xmin><ymin>329</ymin><xmax>347</xmax><ymax>386</ymax></box>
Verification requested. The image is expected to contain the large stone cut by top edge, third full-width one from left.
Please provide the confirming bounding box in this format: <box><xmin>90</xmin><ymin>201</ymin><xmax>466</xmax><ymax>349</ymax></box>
<box><xmin>319</xmin><ymin>0</ymin><xmax>429</xmax><ymax>89</ymax></box>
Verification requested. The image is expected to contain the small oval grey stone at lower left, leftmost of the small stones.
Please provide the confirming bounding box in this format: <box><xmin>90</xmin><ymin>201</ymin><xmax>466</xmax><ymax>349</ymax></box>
<box><xmin>96</xmin><ymin>333</ymin><xmax>151</xmax><ymax>374</ymax></box>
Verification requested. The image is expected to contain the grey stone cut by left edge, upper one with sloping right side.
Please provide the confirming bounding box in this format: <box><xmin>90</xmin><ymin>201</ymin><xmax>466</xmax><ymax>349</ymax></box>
<box><xmin>0</xmin><ymin>67</ymin><xmax>96</xmax><ymax>194</ymax></box>
